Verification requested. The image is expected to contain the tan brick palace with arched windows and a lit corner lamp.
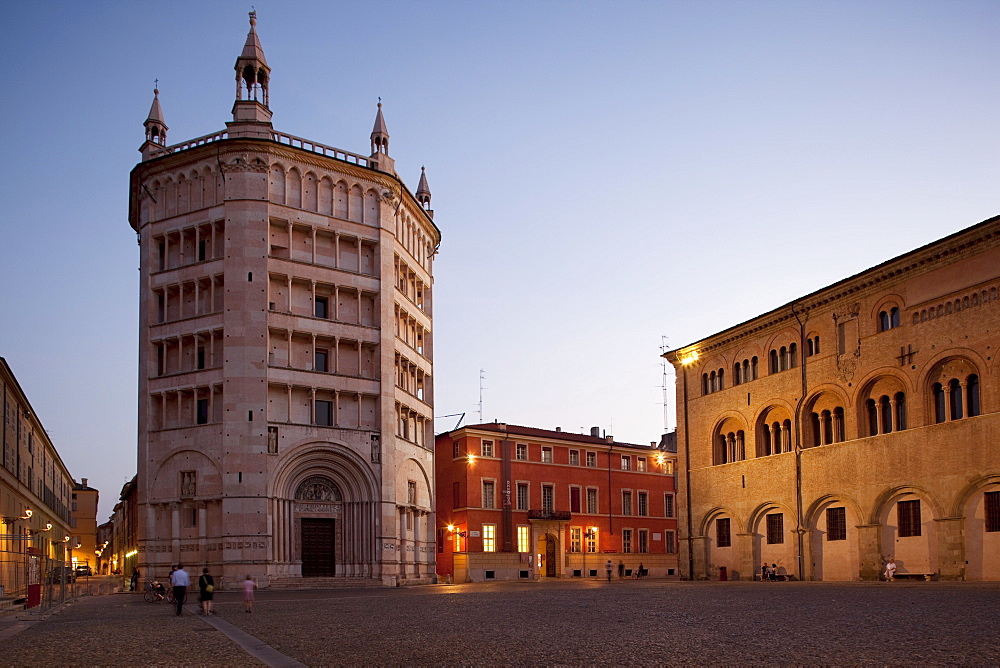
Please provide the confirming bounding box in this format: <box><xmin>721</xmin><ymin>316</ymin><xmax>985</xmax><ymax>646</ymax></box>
<box><xmin>664</xmin><ymin>217</ymin><xmax>1000</xmax><ymax>580</ymax></box>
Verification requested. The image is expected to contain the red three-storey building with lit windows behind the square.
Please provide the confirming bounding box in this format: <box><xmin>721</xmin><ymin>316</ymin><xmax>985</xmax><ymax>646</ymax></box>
<box><xmin>434</xmin><ymin>423</ymin><xmax>677</xmax><ymax>582</ymax></box>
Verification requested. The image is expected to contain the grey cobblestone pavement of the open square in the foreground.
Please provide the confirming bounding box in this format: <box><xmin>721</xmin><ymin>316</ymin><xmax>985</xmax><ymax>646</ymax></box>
<box><xmin>0</xmin><ymin>580</ymin><xmax>1000</xmax><ymax>666</ymax></box>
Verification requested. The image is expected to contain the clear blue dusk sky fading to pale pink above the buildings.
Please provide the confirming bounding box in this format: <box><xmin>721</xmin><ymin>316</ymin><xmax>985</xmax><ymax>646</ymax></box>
<box><xmin>0</xmin><ymin>0</ymin><xmax>1000</xmax><ymax>521</ymax></box>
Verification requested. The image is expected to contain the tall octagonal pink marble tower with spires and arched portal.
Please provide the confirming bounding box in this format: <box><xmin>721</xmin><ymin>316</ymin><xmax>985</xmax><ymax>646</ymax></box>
<box><xmin>129</xmin><ymin>12</ymin><xmax>441</xmax><ymax>586</ymax></box>
